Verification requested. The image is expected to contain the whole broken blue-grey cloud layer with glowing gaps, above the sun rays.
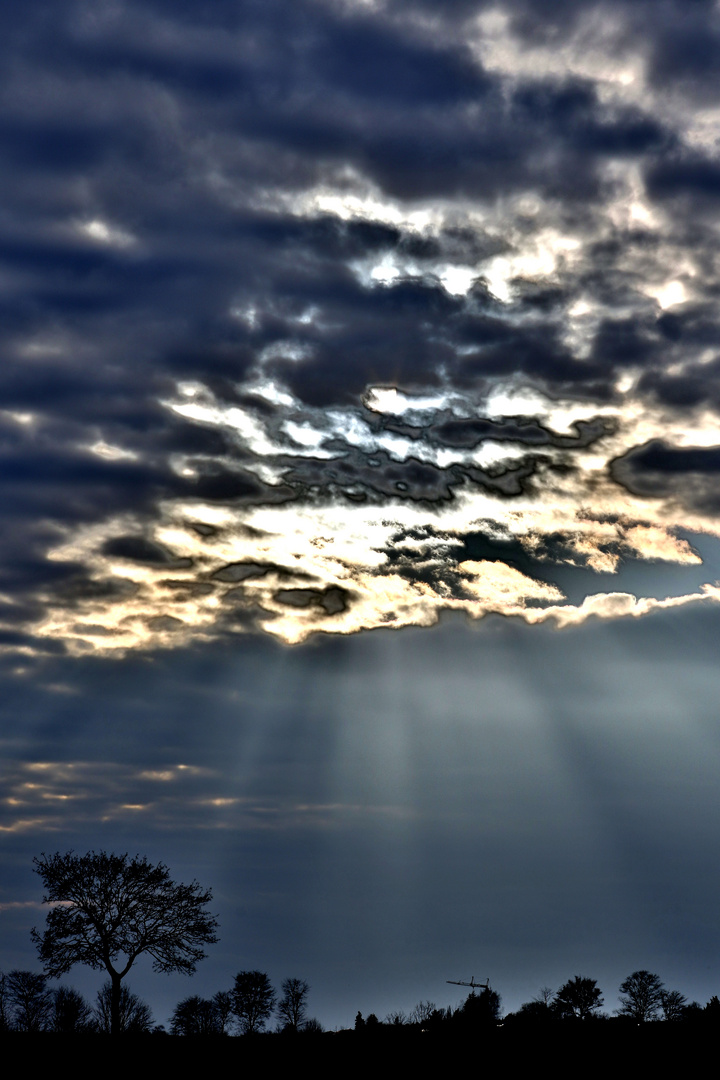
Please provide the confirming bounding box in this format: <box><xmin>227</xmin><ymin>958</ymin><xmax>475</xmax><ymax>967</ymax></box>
<box><xmin>0</xmin><ymin>0</ymin><xmax>720</xmax><ymax>657</ymax></box>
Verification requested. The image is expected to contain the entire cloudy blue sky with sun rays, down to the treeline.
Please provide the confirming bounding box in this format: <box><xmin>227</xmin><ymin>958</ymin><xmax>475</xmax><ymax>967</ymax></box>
<box><xmin>0</xmin><ymin>0</ymin><xmax>720</xmax><ymax>1027</ymax></box>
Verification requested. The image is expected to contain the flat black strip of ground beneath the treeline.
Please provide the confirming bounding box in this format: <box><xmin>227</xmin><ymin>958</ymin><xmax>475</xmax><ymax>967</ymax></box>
<box><xmin>3</xmin><ymin>1023</ymin><xmax>717</xmax><ymax>1077</ymax></box>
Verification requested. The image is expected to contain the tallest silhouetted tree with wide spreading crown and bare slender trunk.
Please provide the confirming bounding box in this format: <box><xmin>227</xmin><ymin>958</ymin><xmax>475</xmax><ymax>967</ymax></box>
<box><xmin>32</xmin><ymin>851</ymin><xmax>217</xmax><ymax>1035</ymax></box>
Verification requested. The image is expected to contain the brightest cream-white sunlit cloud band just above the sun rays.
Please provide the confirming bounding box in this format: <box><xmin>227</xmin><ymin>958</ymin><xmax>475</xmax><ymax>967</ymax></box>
<box><xmin>18</xmin><ymin>375</ymin><xmax>720</xmax><ymax>652</ymax></box>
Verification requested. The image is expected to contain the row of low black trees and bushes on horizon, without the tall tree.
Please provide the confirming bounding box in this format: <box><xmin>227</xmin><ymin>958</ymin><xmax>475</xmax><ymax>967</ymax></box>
<box><xmin>5</xmin><ymin>971</ymin><xmax>720</xmax><ymax>1038</ymax></box>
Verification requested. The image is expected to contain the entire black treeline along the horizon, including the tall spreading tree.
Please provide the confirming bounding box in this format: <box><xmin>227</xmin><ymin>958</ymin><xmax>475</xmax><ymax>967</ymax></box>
<box><xmin>19</xmin><ymin>851</ymin><xmax>720</xmax><ymax>1045</ymax></box>
